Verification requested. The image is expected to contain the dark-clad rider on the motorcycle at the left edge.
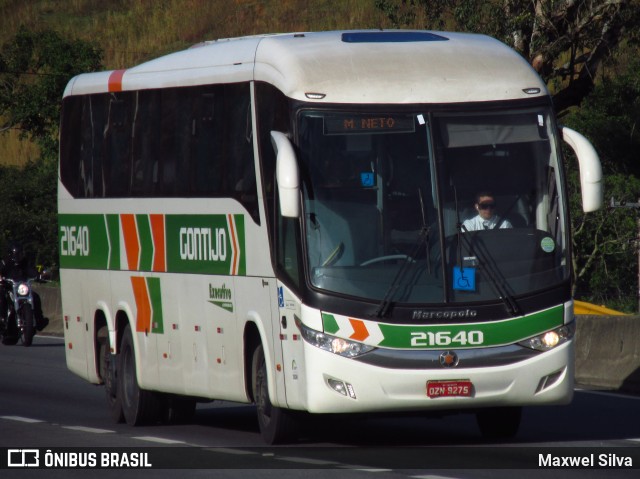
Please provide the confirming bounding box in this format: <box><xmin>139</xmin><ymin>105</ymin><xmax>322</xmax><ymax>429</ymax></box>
<box><xmin>0</xmin><ymin>243</ymin><xmax>49</xmax><ymax>331</ymax></box>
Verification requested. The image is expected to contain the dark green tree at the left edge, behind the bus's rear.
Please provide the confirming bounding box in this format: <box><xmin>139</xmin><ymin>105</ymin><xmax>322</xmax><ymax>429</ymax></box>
<box><xmin>0</xmin><ymin>27</ymin><xmax>102</xmax><ymax>266</ymax></box>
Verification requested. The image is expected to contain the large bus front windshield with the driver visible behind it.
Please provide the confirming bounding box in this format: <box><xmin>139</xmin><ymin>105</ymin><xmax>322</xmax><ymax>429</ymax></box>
<box><xmin>298</xmin><ymin>107</ymin><xmax>569</xmax><ymax>304</ymax></box>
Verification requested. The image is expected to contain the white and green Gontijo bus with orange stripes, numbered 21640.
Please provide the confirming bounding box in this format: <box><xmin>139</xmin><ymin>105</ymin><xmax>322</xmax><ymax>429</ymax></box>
<box><xmin>59</xmin><ymin>31</ymin><xmax>602</xmax><ymax>443</ymax></box>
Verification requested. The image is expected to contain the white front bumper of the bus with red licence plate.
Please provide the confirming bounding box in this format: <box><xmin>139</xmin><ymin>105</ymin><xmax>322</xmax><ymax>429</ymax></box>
<box><xmin>296</xmin><ymin>340</ymin><xmax>574</xmax><ymax>413</ymax></box>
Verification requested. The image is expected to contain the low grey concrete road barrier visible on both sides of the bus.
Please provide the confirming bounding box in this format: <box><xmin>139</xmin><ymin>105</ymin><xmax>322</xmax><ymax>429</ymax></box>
<box><xmin>35</xmin><ymin>285</ymin><xmax>640</xmax><ymax>393</ymax></box>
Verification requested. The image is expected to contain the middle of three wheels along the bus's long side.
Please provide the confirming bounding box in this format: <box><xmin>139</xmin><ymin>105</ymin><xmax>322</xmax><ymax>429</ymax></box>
<box><xmin>118</xmin><ymin>325</ymin><xmax>161</xmax><ymax>426</ymax></box>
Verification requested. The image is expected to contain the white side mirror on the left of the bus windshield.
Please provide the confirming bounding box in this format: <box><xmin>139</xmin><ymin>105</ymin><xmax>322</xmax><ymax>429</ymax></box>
<box><xmin>271</xmin><ymin>131</ymin><xmax>300</xmax><ymax>218</ymax></box>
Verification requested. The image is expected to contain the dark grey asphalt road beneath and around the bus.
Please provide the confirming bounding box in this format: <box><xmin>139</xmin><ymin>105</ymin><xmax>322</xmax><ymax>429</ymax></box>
<box><xmin>0</xmin><ymin>337</ymin><xmax>640</xmax><ymax>479</ymax></box>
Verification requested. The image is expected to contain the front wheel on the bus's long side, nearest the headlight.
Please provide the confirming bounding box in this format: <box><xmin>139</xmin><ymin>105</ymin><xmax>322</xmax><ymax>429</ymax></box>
<box><xmin>251</xmin><ymin>345</ymin><xmax>297</xmax><ymax>444</ymax></box>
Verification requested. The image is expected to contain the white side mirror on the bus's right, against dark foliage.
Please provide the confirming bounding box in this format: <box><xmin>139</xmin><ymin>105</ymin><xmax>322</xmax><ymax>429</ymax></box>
<box><xmin>562</xmin><ymin>126</ymin><xmax>602</xmax><ymax>213</ymax></box>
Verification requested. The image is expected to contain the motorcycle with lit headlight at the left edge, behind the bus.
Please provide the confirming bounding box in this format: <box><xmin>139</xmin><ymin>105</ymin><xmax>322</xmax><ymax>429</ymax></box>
<box><xmin>0</xmin><ymin>277</ymin><xmax>41</xmax><ymax>347</ymax></box>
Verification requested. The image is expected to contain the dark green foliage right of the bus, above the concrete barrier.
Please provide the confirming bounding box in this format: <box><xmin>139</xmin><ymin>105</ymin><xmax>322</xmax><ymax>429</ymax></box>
<box><xmin>566</xmin><ymin>61</ymin><xmax>640</xmax><ymax>311</ymax></box>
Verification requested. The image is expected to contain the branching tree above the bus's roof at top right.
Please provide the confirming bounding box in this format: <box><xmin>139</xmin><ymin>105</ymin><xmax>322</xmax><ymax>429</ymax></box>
<box><xmin>376</xmin><ymin>0</ymin><xmax>640</xmax><ymax>115</ymax></box>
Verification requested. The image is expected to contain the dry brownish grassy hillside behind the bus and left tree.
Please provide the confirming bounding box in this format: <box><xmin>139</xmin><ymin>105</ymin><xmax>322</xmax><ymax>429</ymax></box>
<box><xmin>0</xmin><ymin>0</ymin><xmax>388</xmax><ymax>165</ymax></box>
